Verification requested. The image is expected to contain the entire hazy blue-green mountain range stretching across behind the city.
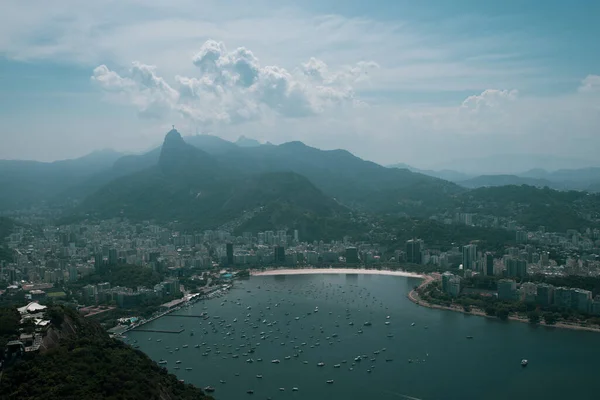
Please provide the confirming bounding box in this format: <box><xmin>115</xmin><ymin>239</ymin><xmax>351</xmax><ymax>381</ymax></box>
<box><xmin>0</xmin><ymin>129</ymin><xmax>600</xmax><ymax>238</ymax></box>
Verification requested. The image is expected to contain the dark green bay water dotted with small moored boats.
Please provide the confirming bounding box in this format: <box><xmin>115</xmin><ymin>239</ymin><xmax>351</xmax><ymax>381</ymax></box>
<box><xmin>127</xmin><ymin>275</ymin><xmax>600</xmax><ymax>400</ymax></box>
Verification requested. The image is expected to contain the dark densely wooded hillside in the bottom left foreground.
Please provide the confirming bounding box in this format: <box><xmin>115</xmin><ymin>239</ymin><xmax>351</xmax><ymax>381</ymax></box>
<box><xmin>0</xmin><ymin>308</ymin><xmax>209</xmax><ymax>400</ymax></box>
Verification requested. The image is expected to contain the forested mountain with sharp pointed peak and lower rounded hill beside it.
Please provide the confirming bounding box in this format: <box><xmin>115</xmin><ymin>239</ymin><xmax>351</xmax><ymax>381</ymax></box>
<box><xmin>80</xmin><ymin>130</ymin><xmax>349</xmax><ymax>239</ymax></box>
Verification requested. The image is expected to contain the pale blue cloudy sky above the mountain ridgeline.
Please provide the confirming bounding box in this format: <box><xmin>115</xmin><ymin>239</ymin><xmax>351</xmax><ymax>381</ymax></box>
<box><xmin>0</xmin><ymin>0</ymin><xmax>600</xmax><ymax>170</ymax></box>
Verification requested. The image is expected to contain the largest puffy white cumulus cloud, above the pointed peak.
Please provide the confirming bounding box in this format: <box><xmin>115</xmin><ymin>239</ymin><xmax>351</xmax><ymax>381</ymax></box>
<box><xmin>92</xmin><ymin>40</ymin><xmax>378</xmax><ymax>124</ymax></box>
